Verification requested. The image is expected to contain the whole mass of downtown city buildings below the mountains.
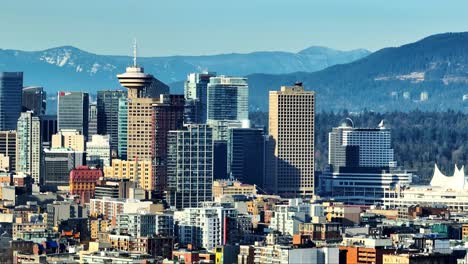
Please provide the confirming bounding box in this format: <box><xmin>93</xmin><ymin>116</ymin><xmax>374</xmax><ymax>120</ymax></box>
<box><xmin>0</xmin><ymin>49</ymin><xmax>468</xmax><ymax>264</ymax></box>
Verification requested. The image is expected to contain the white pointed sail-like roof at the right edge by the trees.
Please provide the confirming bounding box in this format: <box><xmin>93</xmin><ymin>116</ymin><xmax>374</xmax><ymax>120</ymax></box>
<box><xmin>431</xmin><ymin>164</ymin><xmax>468</xmax><ymax>190</ymax></box>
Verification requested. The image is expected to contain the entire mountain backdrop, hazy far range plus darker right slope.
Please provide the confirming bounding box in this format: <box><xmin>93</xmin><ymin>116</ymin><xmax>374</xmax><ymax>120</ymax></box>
<box><xmin>0</xmin><ymin>32</ymin><xmax>468</xmax><ymax>112</ymax></box>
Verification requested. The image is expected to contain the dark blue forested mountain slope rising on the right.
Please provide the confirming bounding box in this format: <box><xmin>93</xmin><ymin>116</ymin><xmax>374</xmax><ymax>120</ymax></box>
<box><xmin>243</xmin><ymin>32</ymin><xmax>468</xmax><ymax>112</ymax></box>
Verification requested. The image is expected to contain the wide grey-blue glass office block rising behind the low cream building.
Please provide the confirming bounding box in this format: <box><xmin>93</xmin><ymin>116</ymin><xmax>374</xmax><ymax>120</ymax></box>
<box><xmin>57</xmin><ymin>92</ymin><xmax>89</xmax><ymax>139</ymax></box>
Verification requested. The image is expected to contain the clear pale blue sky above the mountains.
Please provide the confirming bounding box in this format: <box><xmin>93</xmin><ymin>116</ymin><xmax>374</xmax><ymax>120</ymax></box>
<box><xmin>0</xmin><ymin>0</ymin><xmax>468</xmax><ymax>56</ymax></box>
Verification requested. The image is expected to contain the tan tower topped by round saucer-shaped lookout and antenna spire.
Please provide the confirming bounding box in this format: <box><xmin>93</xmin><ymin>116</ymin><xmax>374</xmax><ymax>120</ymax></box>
<box><xmin>117</xmin><ymin>45</ymin><xmax>159</xmax><ymax>161</ymax></box>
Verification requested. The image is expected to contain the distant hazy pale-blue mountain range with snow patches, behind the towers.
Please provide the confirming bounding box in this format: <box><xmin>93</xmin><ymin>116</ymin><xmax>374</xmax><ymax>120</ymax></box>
<box><xmin>0</xmin><ymin>46</ymin><xmax>370</xmax><ymax>98</ymax></box>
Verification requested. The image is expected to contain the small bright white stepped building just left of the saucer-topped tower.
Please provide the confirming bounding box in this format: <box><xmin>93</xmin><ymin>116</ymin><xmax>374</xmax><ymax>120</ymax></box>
<box><xmin>86</xmin><ymin>135</ymin><xmax>111</xmax><ymax>168</ymax></box>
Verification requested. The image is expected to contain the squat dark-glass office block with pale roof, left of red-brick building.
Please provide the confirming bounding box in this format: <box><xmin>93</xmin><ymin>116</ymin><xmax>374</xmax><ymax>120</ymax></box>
<box><xmin>42</xmin><ymin>148</ymin><xmax>86</xmax><ymax>190</ymax></box>
